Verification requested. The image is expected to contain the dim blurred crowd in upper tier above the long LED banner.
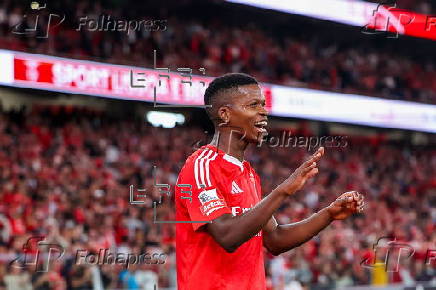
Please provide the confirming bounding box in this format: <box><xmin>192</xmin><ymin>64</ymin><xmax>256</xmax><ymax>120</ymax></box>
<box><xmin>0</xmin><ymin>1</ymin><xmax>436</xmax><ymax>104</ymax></box>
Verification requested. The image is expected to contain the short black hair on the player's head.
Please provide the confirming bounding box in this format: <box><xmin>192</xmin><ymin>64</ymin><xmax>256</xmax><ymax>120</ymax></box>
<box><xmin>204</xmin><ymin>73</ymin><xmax>259</xmax><ymax>121</ymax></box>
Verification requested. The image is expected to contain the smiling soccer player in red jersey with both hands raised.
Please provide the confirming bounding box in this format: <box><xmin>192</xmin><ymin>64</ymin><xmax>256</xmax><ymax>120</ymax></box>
<box><xmin>175</xmin><ymin>73</ymin><xmax>364</xmax><ymax>290</ymax></box>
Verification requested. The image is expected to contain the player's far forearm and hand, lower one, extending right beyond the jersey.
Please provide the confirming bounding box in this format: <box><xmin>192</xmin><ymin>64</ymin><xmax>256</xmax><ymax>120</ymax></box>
<box><xmin>263</xmin><ymin>191</ymin><xmax>364</xmax><ymax>255</ymax></box>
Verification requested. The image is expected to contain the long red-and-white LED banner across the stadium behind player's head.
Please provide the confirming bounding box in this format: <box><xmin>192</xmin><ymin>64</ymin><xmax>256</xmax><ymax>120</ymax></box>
<box><xmin>0</xmin><ymin>50</ymin><xmax>436</xmax><ymax>133</ymax></box>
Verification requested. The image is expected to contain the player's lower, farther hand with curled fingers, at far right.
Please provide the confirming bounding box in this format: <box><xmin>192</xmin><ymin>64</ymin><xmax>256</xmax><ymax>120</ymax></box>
<box><xmin>327</xmin><ymin>191</ymin><xmax>365</xmax><ymax>220</ymax></box>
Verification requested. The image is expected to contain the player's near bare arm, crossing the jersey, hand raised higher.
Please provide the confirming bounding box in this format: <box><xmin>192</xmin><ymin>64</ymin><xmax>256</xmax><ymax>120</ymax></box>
<box><xmin>206</xmin><ymin>147</ymin><xmax>324</xmax><ymax>252</ymax></box>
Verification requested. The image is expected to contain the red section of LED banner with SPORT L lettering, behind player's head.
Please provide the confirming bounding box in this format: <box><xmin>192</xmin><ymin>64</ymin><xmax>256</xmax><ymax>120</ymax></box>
<box><xmin>13</xmin><ymin>53</ymin><xmax>271</xmax><ymax>108</ymax></box>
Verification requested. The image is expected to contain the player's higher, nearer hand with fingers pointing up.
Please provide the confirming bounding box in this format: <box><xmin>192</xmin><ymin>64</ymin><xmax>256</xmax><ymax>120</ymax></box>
<box><xmin>277</xmin><ymin>147</ymin><xmax>324</xmax><ymax>195</ymax></box>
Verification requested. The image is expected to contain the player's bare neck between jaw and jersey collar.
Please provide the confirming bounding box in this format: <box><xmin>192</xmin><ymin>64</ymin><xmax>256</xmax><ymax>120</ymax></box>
<box><xmin>210</xmin><ymin>131</ymin><xmax>248</xmax><ymax>162</ymax></box>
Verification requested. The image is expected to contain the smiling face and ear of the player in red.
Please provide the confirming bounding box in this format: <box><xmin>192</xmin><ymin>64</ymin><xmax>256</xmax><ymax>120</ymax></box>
<box><xmin>218</xmin><ymin>84</ymin><xmax>268</xmax><ymax>143</ymax></box>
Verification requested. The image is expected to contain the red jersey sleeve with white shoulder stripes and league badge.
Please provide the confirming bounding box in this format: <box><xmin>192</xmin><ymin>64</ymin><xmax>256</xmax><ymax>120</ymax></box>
<box><xmin>185</xmin><ymin>154</ymin><xmax>232</xmax><ymax>230</ymax></box>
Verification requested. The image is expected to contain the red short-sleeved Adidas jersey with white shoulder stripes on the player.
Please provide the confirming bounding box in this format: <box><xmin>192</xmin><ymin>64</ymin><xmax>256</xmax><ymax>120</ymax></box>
<box><xmin>175</xmin><ymin>145</ymin><xmax>266</xmax><ymax>290</ymax></box>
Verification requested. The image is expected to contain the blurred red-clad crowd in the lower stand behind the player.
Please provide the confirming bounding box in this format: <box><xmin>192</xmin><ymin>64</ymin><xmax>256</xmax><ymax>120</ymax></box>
<box><xmin>0</xmin><ymin>107</ymin><xmax>436</xmax><ymax>290</ymax></box>
